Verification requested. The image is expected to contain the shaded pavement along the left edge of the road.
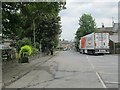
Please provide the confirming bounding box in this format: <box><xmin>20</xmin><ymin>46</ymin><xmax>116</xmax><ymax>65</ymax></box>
<box><xmin>0</xmin><ymin>51</ymin><xmax>58</xmax><ymax>88</ymax></box>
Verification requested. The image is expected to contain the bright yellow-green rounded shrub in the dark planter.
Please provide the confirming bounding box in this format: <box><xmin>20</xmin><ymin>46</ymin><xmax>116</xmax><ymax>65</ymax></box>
<box><xmin>20</xmin><ymin>45</ymin><xmax>32</xmax><ymax>56</ymax></box>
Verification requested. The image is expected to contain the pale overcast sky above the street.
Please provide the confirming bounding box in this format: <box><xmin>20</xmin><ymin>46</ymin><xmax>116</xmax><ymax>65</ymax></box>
<box><xmin>60</xmin><ymin>0</ymin><xmax>119</xmax><ymax>41</ymax></box>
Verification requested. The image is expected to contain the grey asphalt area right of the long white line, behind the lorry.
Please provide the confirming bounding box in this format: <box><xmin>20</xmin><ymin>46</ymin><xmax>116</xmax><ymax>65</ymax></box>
<box><xmin>87</xmin><ymin>55</ymin><xmax>120</xmax><ymax>88</ymax></box>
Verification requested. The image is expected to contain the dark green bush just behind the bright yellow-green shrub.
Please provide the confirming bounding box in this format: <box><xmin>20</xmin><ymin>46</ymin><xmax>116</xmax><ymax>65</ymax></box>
<box><xmin>16</xmin><ymin>38</ymin><xmax>31</xmax><ymax>52</ymax></box>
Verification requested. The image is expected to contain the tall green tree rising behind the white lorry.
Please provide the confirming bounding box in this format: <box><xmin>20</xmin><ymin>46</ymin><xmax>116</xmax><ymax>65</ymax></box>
<box><xmin>75</xmin><ymin>14</ymin><xmax>96</xmax><ymax>51</ymax></box>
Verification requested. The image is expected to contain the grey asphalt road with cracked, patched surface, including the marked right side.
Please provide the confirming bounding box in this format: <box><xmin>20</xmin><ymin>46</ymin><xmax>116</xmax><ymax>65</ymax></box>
<box><xmin>6</xmin><ymin>51</ymin><xmax>118</xmax><ymax>88</ymax></box>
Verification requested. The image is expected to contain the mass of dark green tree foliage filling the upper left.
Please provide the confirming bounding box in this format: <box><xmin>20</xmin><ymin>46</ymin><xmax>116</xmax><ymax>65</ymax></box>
<box><xmin>2</xmin><ymin>2</ymin><xmax>66</xmax><ymax>51</ymax></box>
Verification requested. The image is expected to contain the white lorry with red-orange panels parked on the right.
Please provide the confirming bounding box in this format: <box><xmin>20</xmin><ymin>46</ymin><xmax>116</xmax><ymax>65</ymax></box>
<box><xmin>79</xmin><ymin>33</ymin><xmax>110</xmax><ymax>54</ymax></box>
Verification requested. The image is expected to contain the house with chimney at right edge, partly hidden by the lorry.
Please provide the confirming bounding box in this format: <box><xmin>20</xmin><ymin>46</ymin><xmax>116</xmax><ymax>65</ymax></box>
<box><xmin>98</xmin><ymin>23</ymin><xmax>120</xmax><ymax>53</ymax></box>
